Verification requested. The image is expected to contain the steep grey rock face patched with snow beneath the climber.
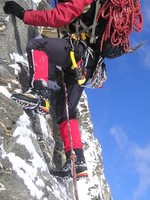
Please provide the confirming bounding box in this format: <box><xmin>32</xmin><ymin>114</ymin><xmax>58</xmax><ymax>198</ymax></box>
<box><xmin>0</xmin><ymin>1</ymin><xmax>112</xmax><ymax>200</ymax></box>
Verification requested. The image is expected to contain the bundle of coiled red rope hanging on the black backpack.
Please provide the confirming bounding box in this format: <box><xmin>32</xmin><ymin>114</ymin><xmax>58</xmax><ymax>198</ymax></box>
<box><xmin>97</xmin><ymin>0</ymin><xmax>143</xmax><ymax>52</ymax></box>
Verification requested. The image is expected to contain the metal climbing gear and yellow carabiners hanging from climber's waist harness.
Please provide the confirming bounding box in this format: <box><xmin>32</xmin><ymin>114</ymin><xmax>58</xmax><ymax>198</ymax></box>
<box><xmin>64</xmin><ymin>34</ymin><xmax>107</xmax><ymax>88</ymax></box>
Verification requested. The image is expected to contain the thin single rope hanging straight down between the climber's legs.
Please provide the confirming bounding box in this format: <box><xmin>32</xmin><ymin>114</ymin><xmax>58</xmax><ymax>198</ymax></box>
<box><xmin>62</xmin><ymin>71</ymin><xmax>79</xmax><ymax>200</ymax></box>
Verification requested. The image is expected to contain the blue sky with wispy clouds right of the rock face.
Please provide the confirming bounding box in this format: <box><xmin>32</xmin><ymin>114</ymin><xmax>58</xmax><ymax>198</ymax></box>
<box><xmin>86</xmin><ymin>1</ymin><xmax>150</xmax><ymax>200</ymax></box>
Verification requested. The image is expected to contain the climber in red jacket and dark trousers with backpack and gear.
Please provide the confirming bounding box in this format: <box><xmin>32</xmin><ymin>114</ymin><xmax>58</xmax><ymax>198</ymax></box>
<box><xmin>3</xmin><ymin>0</ymin><xmax>142</xmax><ymax>177</ymax></box>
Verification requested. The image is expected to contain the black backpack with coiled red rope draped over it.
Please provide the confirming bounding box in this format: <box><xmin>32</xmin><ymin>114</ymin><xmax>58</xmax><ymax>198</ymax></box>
<box><xmin>75</xmin><ymin>0</ymin><xmax>143</xmax><ymax>58</ymax></box>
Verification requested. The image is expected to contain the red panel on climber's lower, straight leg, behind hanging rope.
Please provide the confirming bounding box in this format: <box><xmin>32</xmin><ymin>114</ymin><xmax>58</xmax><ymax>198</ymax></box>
<box><xmin>59</xmin><ymin>119</ymin><xmax>83</xmax><ymax>152</ymax></box>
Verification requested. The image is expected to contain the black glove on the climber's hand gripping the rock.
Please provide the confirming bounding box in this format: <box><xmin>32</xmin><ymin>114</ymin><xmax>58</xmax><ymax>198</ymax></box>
<box><xmin>3</xmin><ymin>1</ymin><xmax>25</xmax><ymax>20</ymax></box>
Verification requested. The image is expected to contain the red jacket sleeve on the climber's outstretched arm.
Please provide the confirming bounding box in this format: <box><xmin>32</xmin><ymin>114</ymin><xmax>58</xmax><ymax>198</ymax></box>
<box><xmin>23</xmin><ymin>0</ymin><xmax>95</xmax><ymax>28</ymax></box>
